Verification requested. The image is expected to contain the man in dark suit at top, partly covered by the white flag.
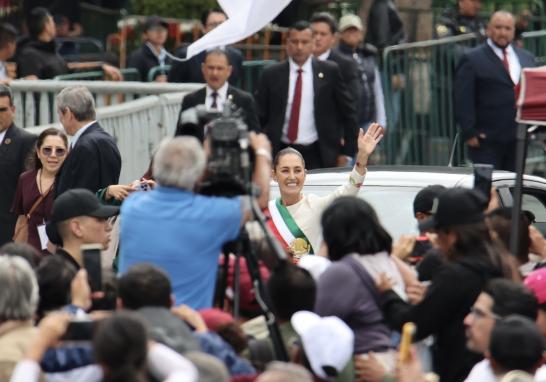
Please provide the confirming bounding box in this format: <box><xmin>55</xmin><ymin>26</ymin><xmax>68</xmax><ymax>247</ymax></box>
<box><xmin>168</xmin><ymin>9</ymin><xmax>244</xmax><ymax>85</ymax></box>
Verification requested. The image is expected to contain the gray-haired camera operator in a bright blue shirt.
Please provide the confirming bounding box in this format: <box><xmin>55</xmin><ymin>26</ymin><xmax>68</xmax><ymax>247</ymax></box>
<box><xmin>119</xmin><ymin>133</ymin><xmax>271</xmax><ymax>309</ymax></box>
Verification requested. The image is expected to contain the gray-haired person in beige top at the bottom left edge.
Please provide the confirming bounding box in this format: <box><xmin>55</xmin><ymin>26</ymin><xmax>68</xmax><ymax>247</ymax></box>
<box><xmin>0</xmin><ymin>255</ymin><xmax>38</xmax><ymax>381</ymax></box>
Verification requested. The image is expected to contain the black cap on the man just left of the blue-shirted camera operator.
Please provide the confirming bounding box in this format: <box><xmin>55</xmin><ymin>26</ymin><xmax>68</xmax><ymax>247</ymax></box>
<box><xmin>46</xmin><ymin>188</ymin><xmax>119</xmax><ymax>245</ymax></box>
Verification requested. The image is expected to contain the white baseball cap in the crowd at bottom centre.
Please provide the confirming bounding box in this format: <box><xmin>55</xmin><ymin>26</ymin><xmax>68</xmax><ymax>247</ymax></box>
<box><xmin>290</xmin><ymin>310</ymin><xmax>354</xmax><ymax>378</ymax></box>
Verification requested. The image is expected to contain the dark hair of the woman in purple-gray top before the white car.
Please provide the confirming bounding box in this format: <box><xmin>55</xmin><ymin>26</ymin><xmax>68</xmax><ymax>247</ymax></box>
<box><xmin>321</xmin><ymin>196</ymin><xmax>392</xmax><ymax>261</ymax></box>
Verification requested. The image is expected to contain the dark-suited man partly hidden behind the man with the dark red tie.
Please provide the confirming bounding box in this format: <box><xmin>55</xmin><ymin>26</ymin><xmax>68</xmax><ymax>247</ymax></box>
<box><xmin>311</xmin><ymin>12</ymin><xmax>362</xmax><ymax>122</ymax></box>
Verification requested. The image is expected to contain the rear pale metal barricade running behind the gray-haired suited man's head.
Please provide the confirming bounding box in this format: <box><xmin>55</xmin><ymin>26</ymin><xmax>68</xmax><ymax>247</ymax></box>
<box><xmin>10</xmin><ymin>80</ymin><xmax>203</xmax><ymax>126</ymax></box>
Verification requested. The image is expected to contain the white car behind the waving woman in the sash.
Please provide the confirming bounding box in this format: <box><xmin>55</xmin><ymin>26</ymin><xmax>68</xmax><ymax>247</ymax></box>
<box><xmin>271</xmin><ymin>166</ymin><xmax>546</xmax><ymax>239</ymax></box>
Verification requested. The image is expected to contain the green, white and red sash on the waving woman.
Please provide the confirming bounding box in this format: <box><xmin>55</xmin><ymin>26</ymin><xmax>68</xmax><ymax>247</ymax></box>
<box><xmin>268</xmin><ymin>198</ymin><xmax>313</xmax><ymax>253</ymax></box>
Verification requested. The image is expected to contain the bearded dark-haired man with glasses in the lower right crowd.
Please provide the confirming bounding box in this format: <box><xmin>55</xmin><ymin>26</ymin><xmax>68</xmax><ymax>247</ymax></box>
<box><xmin>464</xmin><ymin>279</ymin><xmax>538</xmax><ymax>382</ymax></box>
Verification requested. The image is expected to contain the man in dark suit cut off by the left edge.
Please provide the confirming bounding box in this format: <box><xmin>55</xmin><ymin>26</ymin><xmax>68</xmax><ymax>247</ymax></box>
<box><xmin>0</xmin><ymin>85</ymin><xmax>36</xmax><ymax>246</ymax></box>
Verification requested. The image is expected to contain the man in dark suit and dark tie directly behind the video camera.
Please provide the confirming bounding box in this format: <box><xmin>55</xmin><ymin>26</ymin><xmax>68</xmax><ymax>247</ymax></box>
<box><xmin>175</xmin><ymin>49</ymin><xmax>260</xmax><ymax>140</ymax></box>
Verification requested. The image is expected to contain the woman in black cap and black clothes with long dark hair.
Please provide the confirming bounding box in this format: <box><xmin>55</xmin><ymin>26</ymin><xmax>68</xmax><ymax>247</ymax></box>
<box><xmin>378</xmin><ymin>188</ymin><xmax>514</xmax><ymax>382</ymax></box>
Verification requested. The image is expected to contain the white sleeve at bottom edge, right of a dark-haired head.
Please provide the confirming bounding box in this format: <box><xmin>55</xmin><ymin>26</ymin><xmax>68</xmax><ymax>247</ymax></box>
<box><xmin>148</xmin><ymin>343</ymin><xmax>199</xmax><ymax>382</ymax></box>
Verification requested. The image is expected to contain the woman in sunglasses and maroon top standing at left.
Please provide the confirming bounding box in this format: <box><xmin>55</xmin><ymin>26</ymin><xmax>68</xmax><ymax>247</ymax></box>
<box><xmin>11</xmin><ymin>128</ymin><xmax>68</xmax><ymax>255</ymax></box>
